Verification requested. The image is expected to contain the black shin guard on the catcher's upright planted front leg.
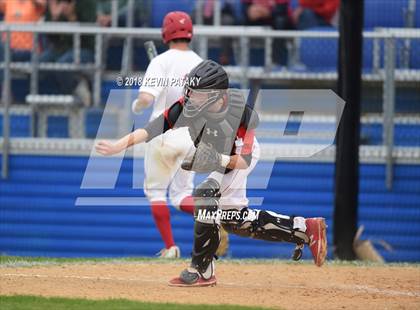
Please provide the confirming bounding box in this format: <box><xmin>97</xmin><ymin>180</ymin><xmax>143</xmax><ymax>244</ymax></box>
<box><xmin>191</xmin><ymin>179</ymin><xmax>220</xmax><ymax>277</ymax></box>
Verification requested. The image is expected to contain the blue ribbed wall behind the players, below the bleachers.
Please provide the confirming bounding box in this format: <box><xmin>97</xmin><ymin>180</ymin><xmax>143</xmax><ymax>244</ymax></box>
<box><xmin>0</xmin><ymin>155</ymin><xmax>420</xmax><ymax>261</ymax></box>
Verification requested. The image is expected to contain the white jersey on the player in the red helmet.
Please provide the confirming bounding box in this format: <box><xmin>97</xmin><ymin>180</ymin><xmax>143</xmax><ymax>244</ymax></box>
<box><xmin>139</xmin><ymin>49</ymin><xmax>203</xmax><ymax>120</ymax></box>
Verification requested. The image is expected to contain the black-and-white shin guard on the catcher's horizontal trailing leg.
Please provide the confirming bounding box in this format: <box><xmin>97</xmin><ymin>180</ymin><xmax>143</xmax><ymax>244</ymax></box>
<box><xmin>222</xmin><ymin>208</ymin><xmax>309</xmax><ymax>245</ymax></box>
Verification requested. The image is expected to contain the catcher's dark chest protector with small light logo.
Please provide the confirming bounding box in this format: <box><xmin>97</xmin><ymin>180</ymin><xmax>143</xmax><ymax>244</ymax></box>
<box><xmin>189</xmin><ymin>90</ymin><xmax>246</xmax><ymax>155</ymax></box>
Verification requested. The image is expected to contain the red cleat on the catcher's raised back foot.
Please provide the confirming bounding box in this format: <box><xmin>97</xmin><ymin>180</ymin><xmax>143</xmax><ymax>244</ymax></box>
<box><xmin>305</xmin><ymin>217</ymin><xmax>327</xmax><ymax>267</ymax></box>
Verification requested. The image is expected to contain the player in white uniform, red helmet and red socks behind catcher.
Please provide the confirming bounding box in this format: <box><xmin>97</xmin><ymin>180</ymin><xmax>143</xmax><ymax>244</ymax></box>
<box><xmin>132</xmin><ymin>11</ymin><xmax>202</xmax><ymax>258</ymax></box>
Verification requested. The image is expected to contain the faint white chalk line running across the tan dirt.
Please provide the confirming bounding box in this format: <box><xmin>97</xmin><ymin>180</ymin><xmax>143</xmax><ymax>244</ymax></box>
<box><xmin>0</xmin><ymin>273</ymin><xmax>420</xmax><ymax>297</ymax></box>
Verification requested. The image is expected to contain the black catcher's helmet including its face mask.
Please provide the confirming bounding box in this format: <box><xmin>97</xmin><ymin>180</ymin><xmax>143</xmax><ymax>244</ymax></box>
<box><xmin>182</xmin><ymin>60</ymin><xmax>229</xmax><ymax>117</ymax></box>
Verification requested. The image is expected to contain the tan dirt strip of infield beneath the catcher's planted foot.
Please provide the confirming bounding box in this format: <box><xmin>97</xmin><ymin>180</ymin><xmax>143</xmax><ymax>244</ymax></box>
<box><xmin>0</xmin><ymin>261</ymin><xmax>420</xmax><ymax>310</ymax></box>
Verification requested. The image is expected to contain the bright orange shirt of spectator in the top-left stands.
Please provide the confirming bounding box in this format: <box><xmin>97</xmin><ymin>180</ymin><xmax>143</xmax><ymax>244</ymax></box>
<box><xmin>0</xmin><ymin>0</ymin><xmax>46</xmax><ymax>50</ymax></box>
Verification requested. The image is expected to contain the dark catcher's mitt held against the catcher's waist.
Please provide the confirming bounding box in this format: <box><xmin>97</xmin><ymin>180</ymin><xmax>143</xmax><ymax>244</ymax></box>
<box><xmin>181</xmin><ymin>143</ymin><xmax>222</xmax><ymax>173</ymax></box>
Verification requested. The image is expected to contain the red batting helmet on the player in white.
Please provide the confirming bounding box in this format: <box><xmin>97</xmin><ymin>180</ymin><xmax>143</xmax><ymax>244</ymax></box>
<box><xmin>162</xmin><ymin>11</ymin><xmax>192</xmax><ymax>44</ymax></box>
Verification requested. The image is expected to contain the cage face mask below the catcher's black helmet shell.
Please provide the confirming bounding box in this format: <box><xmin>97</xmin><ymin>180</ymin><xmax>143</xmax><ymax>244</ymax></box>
<box><xmin>182</xmin><ymin>86</ymin><xmax>225</xmax><ymax>117</ymax></box>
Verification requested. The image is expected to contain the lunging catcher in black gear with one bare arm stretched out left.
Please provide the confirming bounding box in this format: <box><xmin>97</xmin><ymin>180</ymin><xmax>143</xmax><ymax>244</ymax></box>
<box><xmin>96</xmin><ymin>60</ymin><xmax>327</xmax><ymax>287</ymax></box>
